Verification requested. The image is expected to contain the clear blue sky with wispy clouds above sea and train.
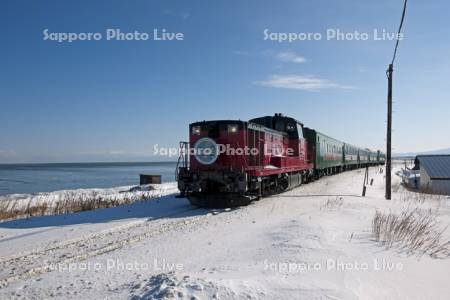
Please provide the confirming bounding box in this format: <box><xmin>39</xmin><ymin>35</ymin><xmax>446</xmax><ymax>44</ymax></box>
<box><xmin>0</xmin><ymin>0</ymin><xmax>450</xmax><ymax>162</ymax></box>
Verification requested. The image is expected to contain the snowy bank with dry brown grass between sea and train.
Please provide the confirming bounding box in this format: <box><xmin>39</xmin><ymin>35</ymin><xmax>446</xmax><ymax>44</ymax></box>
<box><xmin>0</xmin><ymin>182</ymin><xmax>177</xmax><ymax>220</ymax></box>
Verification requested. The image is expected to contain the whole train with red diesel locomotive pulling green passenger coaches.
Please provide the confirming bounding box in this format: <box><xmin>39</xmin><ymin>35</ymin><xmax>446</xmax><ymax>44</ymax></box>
<box><xmin>177</xmin><ymin>113</ymin><xmax>385</xmax><ymax>207</ymax></box>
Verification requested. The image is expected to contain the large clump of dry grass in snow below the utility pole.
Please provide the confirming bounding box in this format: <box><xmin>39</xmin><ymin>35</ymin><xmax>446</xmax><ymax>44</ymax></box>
<box><xmin>372</xmin><ymin>208</ymin><xmax>450</xmax><ymax>258</ymax></box>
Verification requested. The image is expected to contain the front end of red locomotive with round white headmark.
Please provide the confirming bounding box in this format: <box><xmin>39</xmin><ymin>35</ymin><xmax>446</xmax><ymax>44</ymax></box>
<box><xmin>178</xmin><ymin>120</ymin><xmax>251</xmax><ymax>207</ymax></box>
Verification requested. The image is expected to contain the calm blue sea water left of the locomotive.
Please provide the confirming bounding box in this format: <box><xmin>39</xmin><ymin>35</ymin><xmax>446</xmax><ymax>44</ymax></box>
<box><xmin>0</xmin><ymin>162</ymin><xmax>176</xmax><ymax>195</ymax></box>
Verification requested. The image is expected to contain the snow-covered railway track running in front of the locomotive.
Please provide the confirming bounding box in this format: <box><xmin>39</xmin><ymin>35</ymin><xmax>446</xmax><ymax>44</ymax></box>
<box><xmin>0</xmin><ymin>207</ymin><xmax>210</xmax><ymax>287</ymax></box>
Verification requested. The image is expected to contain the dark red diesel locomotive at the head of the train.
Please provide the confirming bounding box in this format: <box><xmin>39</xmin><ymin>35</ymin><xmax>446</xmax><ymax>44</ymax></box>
<box><xmin>178</xmin><ymin>115</ymin><xmax>313</xmax><ymax>206</ymax></box>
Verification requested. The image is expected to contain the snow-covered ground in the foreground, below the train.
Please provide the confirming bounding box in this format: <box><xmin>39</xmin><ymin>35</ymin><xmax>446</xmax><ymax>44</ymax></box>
<box><xmin>0</xmin><ymin>168</ymin><xmax>450</xmax><ymax>299</ymax></box>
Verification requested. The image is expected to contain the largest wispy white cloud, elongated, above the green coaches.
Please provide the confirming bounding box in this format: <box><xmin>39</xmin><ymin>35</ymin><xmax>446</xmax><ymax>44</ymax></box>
<box><xmin>255</xmin><ymin>75</ymin><xmax>354</xmax><ymax>91</ymax></box>
